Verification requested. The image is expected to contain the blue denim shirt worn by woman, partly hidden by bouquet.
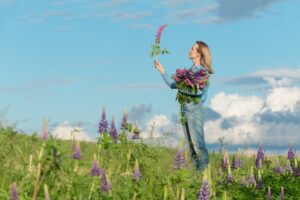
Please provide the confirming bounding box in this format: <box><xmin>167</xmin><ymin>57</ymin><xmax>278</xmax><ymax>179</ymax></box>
<box><xmin>161</xmin><ymin>65</ymin><xmax>209</xmax><ymax>103</ymax></box>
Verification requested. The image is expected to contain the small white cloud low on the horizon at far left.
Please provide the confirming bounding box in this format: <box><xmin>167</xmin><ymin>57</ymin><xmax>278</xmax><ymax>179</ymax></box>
<box><xmin>51</xmin><ymin>121</ymin><xmax>92</xmax><ymax>141</ymax></box>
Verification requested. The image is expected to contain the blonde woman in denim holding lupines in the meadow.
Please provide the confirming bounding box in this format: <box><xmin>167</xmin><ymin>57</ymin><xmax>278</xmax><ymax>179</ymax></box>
<box><xmin>154</xmin><ymin>41</ymin><xmax>214</xmax><ymax>171</ymax></box>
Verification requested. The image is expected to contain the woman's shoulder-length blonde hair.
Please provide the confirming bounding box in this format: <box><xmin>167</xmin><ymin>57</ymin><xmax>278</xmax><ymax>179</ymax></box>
<box><xmin>196</xmin><ymin>41</ymin><xmax>214</xmax><ymax>74</ymax></box>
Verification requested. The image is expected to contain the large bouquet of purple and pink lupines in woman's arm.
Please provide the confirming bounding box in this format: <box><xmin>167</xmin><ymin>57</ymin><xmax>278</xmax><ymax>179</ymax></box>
<box><xmin>172</xmin><ymin>68</ymin><xmax>209</xmax><ymax>105</ymax></box>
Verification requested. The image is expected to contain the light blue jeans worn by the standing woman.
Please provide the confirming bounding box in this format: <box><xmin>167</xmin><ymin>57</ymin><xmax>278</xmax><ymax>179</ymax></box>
<box><xmin>180</xmin><ymin>102</ymin><xmax>209</xmax><ymax>171</ymax></box>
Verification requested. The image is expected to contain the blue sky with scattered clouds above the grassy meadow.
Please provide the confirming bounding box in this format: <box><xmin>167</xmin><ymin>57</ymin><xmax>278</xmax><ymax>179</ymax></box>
<box><xmin>0</xmin><ymin>0</ymin><xmax>300</xmax><ymax>155</ymax></box>
